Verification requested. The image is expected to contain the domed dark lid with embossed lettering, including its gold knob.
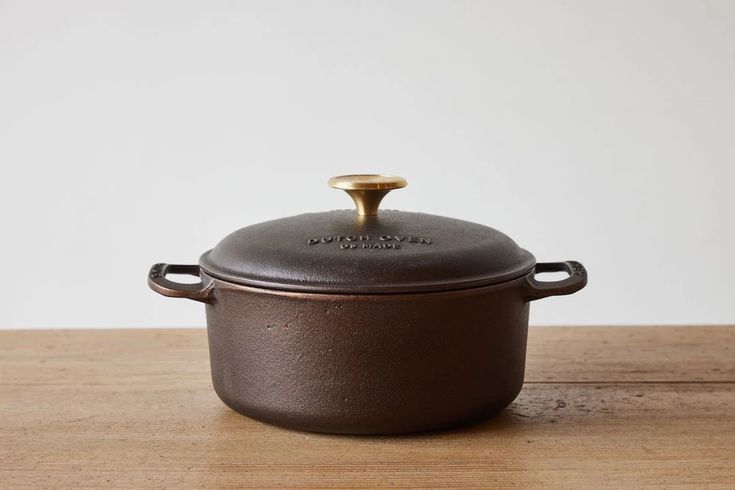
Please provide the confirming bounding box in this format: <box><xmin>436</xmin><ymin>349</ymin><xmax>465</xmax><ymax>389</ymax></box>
<box><xmin>200</xmin><ymin>175</ymin><xmax>536</xmax><ymax>294</ymax></box>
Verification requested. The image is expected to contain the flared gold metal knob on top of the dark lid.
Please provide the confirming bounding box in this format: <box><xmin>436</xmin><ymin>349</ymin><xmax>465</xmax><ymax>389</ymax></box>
<box><xmin>329</xmin><ymin>174</ymin><xmax>408</xmax><ymax>216</ymax></box>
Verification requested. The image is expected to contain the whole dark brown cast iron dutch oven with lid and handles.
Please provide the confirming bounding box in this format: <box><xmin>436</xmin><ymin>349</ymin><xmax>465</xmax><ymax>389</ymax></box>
<box><xmin>148</xmin><ymin>175</ymin><xmax>587</xmax><ymax>434</ymax></box>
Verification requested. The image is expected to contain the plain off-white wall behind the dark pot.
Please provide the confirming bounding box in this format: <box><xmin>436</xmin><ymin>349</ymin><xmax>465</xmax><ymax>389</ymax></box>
<box><xmin>0</xmin><ymin>0</ymin><xmax>735</xmax><ymax>328</ymax></box>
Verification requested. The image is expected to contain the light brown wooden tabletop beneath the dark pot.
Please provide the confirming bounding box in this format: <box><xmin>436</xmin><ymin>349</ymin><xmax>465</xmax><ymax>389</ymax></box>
<box><xmin>0</xmin><ymin>327</ymin><xmax>735</xmax><ymax>488</ymax></box>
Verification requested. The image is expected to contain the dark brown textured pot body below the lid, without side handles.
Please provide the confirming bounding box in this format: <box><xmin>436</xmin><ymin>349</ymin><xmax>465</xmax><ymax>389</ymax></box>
<box><xmin>206</xmin><ymin>274</ymin><xmax>529</xmax><ymax>434</ymax></box>
